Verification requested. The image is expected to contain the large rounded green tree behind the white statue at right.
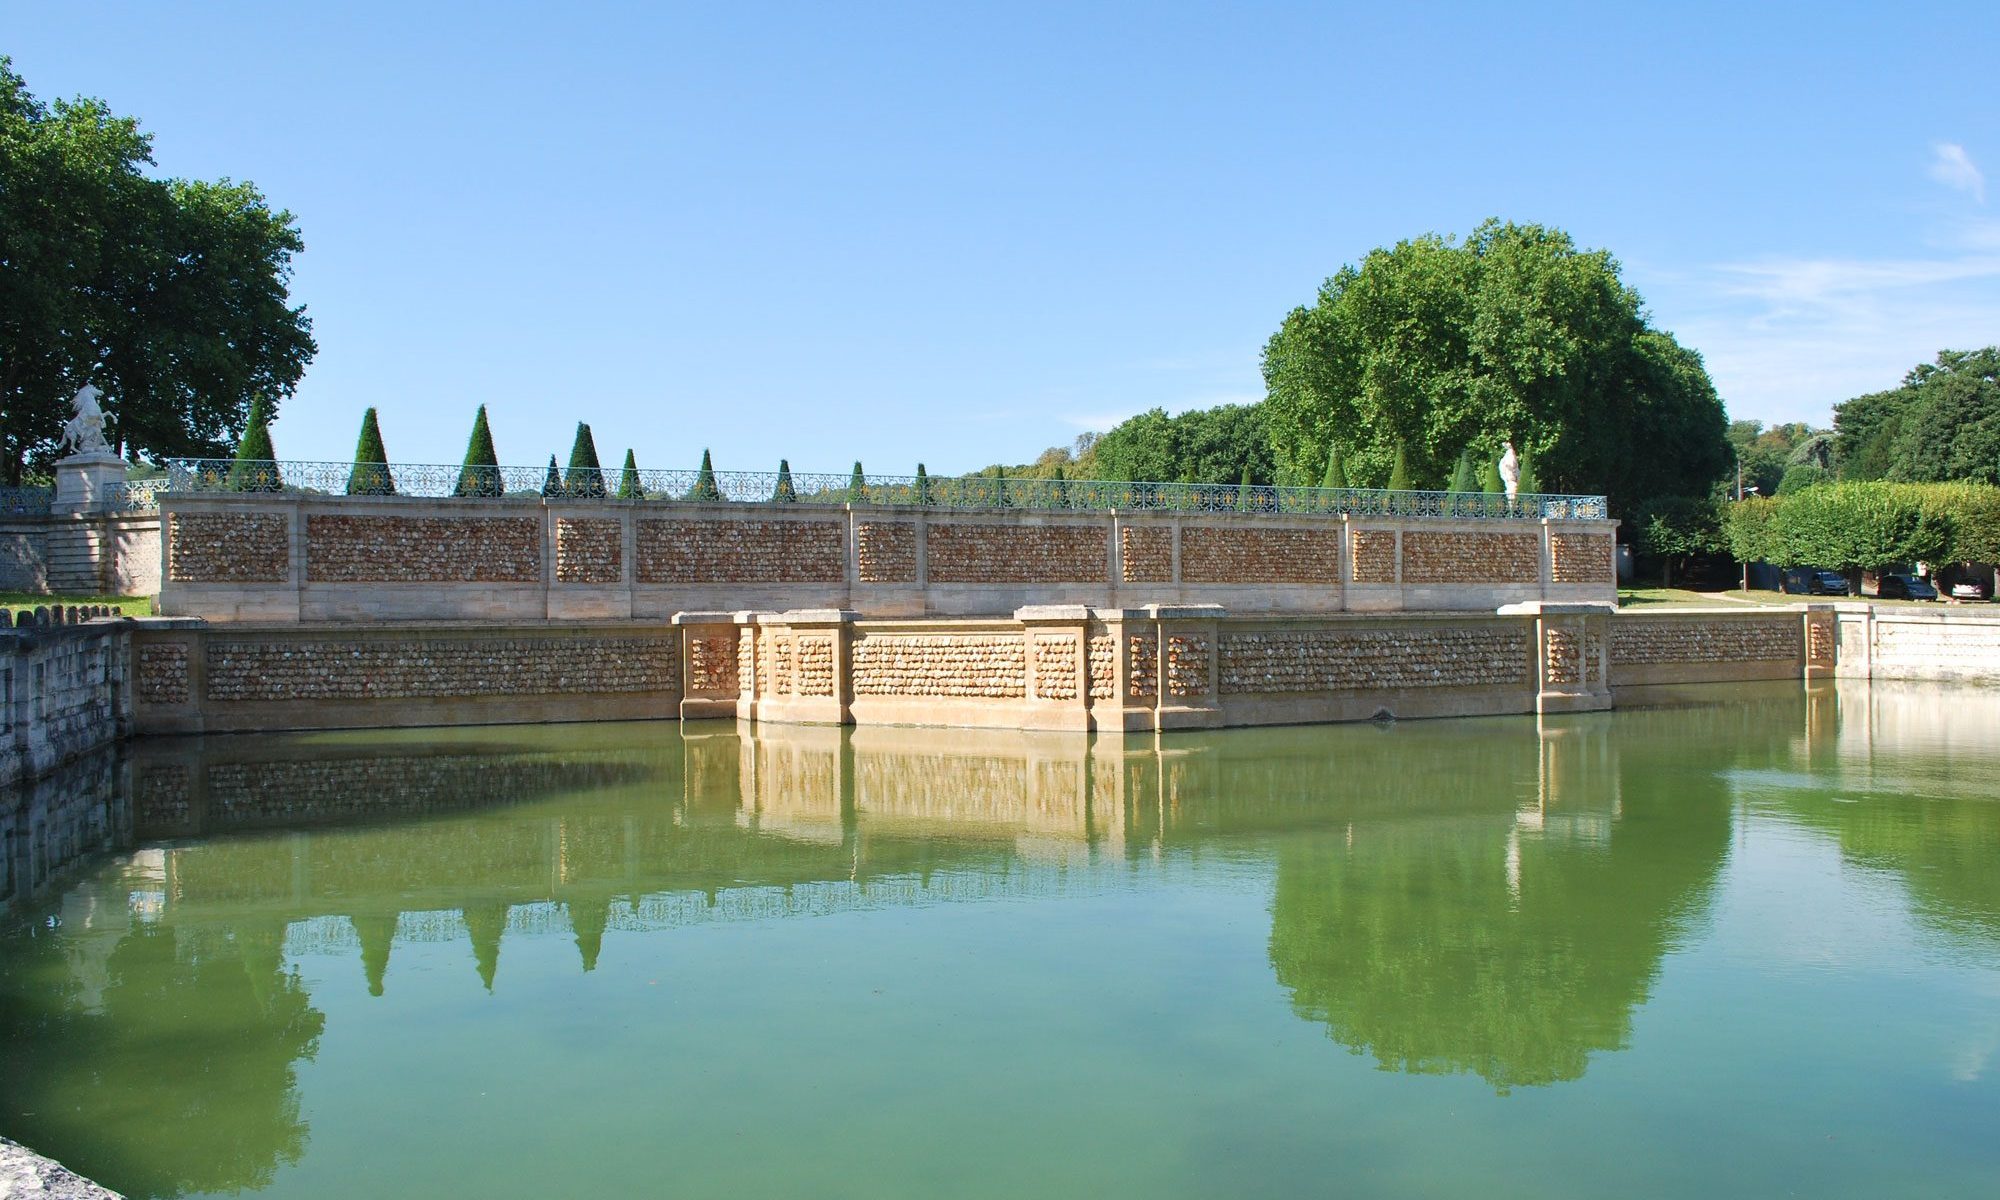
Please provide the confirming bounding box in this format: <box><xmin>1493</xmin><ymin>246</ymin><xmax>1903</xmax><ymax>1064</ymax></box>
<box><xmin>1264</xmin><ymin>220</ymin><xmax>1732</xmax><ymax>510</ymax></box>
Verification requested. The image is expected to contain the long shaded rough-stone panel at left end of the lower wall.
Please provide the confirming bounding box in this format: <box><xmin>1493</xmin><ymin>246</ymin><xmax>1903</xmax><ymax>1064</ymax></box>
<box><xmin>204</xmin><ymin>638</ymin><xmax>680</xmax><ymax>702</ymax></box>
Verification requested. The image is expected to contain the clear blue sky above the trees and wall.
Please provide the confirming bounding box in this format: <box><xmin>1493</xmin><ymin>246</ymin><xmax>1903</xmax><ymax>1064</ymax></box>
<box><xmin>0</xmin><ymin>0</ymin><xmax>2000</xmax><ymax>472</ymax></box>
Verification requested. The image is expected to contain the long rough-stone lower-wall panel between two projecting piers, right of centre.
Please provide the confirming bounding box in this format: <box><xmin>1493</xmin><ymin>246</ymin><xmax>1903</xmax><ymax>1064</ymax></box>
<box><xmin>1220</xmin><ymin>626</ymin><xmax>1534</xmax><ymax>694</ymax></box>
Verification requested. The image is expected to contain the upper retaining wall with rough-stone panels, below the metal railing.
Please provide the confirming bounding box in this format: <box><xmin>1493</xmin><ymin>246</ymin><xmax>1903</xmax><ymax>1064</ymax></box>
<box><xmin>160</xmin><ymin>494</ymin><xmax>1616</xmax><ymax>622</ymax></box>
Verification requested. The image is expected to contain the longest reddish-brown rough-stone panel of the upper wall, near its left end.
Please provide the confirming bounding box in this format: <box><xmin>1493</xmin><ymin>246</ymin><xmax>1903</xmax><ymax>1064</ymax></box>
<box><xmin>306</xmin><ymin>512</ymin><xmax>542</xmax><ymax>584</ymax></box>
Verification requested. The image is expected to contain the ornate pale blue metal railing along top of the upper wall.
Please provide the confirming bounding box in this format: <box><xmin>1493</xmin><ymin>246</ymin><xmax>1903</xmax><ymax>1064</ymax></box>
<box><xmin>166</xmin><ymin>458</ymin><xmax>1606</xmax><ymax>520</ymax></box>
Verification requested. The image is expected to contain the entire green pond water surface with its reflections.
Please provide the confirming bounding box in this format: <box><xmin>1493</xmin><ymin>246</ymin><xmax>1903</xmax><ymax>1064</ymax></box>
<box><xmin>0</xmin><ymin>684</ymin><xmax>2000</xmax><ymax>1198</ymax></box>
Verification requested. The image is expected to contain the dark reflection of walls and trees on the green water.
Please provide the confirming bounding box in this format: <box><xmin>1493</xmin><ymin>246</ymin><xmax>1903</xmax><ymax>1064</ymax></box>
<box><xmin>0</xmin><ymin>686</ymin><xmax>2000</xmax><ymax>1196</ymax></box>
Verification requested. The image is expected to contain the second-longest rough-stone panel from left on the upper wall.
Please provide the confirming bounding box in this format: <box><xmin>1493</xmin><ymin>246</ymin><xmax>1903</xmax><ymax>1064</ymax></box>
<box><xmin>638</xmin><ymin>520</ymin><xmax>846</xmax><ymax>584</ymax></box>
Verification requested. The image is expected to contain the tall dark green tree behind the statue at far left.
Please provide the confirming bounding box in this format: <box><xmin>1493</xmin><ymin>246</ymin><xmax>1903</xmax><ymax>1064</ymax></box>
<box><xmin>0</xmin><ymin>58</ymin><xmax>316</xmax><ymax>484</ymax></box>
